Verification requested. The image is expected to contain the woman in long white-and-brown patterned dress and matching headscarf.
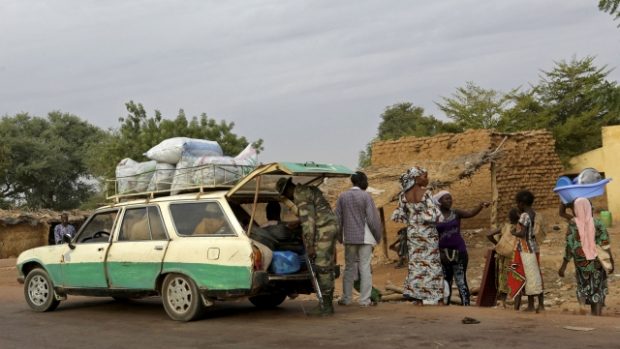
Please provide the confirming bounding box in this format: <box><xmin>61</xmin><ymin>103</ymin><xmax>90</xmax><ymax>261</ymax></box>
<box><xmin>392</xmin><ymin>166</ymin><xmax>444</xmax><ymax>305</ymax></box>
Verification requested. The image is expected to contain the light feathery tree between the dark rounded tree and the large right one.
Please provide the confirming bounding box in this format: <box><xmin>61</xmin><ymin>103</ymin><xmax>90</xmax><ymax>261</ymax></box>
<box><xmin>436</xmin><ymin>81</ymin><xmax>509</xmax><ymax>129</ymax></box>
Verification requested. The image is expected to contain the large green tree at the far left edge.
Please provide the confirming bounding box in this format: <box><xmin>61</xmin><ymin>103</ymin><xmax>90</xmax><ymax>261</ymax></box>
<box><xmin>0</xmin><ymin>112</ymin><xmax>103</xmax><ymax>210</ymax></box>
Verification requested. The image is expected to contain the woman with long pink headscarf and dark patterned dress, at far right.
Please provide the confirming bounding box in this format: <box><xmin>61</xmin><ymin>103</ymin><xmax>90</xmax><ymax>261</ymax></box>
<box><xmin>558</xmin><ymin>198</ymin><xmax>613</xmax><ymax>315</ymax></box>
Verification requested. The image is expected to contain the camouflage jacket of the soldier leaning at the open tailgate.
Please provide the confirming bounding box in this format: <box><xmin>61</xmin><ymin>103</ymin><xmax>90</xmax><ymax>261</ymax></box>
<box><xmin>294</xmin><ymin>185</ymin><xmax>338</xmax><ymax>247</ymax></box>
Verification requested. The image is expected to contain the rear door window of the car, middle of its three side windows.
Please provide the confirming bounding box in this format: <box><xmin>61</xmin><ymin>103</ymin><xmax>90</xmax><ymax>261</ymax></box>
<box><xmin>118</xmin><ymin>206</ymin><xmax>167</xmax><ymax>241</ymax></box>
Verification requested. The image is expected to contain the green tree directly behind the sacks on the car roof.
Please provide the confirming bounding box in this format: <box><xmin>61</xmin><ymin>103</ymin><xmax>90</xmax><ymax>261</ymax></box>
<box><xmin>90</xmin><ymin>101</ymin><xmax>263</xmax><ymax>178</ymax></box>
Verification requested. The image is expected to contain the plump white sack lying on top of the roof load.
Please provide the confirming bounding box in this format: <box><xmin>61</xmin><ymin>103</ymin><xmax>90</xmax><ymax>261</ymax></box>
<box><xmin>144</xmin><ymin>137</ymin><xmax>224</xmax><ymax>165</ymax></box>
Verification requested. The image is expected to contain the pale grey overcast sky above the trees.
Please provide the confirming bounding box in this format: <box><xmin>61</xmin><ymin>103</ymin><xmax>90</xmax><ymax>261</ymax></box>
<box><xmin>0</xmin><ymin>0</ymin><xmax>620</xmax><ymax>168</ymax></box>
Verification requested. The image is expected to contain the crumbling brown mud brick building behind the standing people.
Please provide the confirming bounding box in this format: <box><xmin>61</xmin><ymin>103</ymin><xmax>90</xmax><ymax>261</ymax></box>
<box><xmin>366</xmin><ymin>130</ymin><xmax>563</xmax><ymax>231</ymax></box>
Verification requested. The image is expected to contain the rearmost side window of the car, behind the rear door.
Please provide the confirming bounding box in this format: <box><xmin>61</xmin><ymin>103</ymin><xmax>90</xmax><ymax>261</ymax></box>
<box><xmin>170</xmin><ymin>202</ymin><xmax>234</xmax><ymax>236</ymax></box>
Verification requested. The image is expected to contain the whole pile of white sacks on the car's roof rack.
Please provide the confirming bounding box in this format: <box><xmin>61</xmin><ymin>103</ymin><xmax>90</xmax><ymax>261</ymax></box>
<box><xmin>108</xmin><ymin>137</ymin><xmax>258</xmax><ymax>199</ymax></box>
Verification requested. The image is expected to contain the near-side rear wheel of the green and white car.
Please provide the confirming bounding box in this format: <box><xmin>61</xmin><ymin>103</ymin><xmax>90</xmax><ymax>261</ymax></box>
<box><xmin>161</xmin><ymin>274</ymin><xmax>204</xmax><ymax>321</ymax></box>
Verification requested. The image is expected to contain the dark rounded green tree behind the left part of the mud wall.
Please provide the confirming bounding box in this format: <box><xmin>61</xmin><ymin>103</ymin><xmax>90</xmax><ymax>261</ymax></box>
<box><xmin>358</xmin><ymin>102</ymin><xmax>461</xmax><ymax>168</ymax></box>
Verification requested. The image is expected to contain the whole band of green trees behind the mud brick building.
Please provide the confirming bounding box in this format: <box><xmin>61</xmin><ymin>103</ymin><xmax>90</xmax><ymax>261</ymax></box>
<box><xmin>359</xmin><ymin>56</ymin><xmax>620</xmax><ymax>166</ymax></box>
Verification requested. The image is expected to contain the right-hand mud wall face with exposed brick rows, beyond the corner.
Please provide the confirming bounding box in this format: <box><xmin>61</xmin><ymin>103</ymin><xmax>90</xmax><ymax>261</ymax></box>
<box><xmin>491</xmin><ymin>131</ymin><xmax>563</xmax><ymax>223</ymax></box>
